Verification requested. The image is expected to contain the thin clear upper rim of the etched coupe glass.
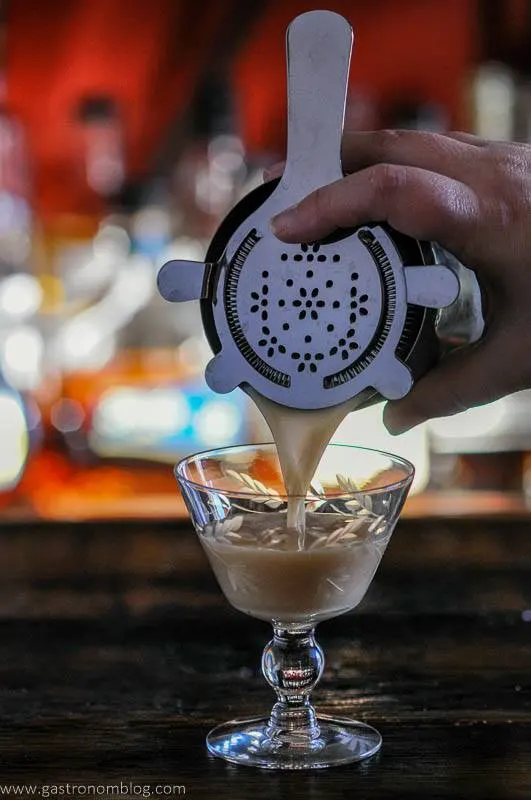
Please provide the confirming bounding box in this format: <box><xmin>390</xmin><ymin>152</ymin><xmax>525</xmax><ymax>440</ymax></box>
<box><xmin>173</xmin><ymin>442</ymin><xmax>415</xmax><ymax>502</ymax></box>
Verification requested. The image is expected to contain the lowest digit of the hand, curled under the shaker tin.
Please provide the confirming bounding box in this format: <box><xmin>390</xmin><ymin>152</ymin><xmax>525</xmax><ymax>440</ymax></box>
<box><xmin>384</xmin><ymin>336</ymin><xmax>522</xmax><ymax>435</ymax></box>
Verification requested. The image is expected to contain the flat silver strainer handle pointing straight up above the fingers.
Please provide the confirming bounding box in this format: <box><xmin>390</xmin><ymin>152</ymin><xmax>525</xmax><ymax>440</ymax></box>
<box><xmin>279</xmin><ymin>11</ymin><xmax>353</xmax><ymax>205</ymax></box>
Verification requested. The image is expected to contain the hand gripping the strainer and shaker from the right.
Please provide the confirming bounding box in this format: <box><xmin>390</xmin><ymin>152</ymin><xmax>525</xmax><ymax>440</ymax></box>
<box><xmin>267</xmin><ymin>131</ymin><xmax>531</xmax><ymax>433</ymax></box>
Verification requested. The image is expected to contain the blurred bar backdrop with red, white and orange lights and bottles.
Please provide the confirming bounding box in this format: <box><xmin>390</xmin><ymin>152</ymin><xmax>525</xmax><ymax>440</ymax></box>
<box><xmin>0</xmin><ymin>0</ymin><xmax>531</xmax><ymax>520</ymax></box>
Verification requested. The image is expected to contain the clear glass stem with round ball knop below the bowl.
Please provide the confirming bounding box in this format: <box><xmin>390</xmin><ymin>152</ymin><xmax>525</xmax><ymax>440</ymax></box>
<box><xmin>262</xmin><ymin>626</ymin><xmax>324</xmax><ymax>744</ymax></box>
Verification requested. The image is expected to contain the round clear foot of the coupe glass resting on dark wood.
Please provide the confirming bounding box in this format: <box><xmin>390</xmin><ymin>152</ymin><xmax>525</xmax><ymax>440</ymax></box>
<box><xmin>206</xmin><ymin>716</ymin><xmax>382</xmax><ymax>769</ymax></box>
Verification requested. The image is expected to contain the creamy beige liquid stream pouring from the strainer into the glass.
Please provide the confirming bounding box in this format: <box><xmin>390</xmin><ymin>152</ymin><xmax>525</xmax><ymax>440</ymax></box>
<box><xmin>247</xmin><ymin>389</ymin><xmax>353</xmax><ymax>549</ymax></box>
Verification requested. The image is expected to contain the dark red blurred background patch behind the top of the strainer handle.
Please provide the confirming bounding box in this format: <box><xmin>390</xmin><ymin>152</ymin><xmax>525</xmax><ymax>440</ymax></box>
<box><xmin>235</xmin><ymin>0</ymin><xmax>477</xmax><ymax>157</ymax></box>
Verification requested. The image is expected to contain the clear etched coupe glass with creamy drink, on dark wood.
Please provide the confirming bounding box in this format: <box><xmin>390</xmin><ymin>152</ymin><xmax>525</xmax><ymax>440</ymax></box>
<box><xmin>175</xmin><ymin>444</ymin><xmax>414</xmax><ymax>769</ymax></box>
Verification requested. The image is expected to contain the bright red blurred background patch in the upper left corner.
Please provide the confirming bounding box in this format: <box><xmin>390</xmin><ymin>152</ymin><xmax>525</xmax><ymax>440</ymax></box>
<box><xmin>7</xmin><ymin>0</ymin><xmax>224</xmax><ymax>216</ymax></box>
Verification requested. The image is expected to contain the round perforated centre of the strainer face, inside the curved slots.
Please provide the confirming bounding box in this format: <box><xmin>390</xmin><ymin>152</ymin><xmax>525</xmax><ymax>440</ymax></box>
<box><xmin>234</xmin><ymin>234</ymin><xmax>378</xmax><ymax>383</ymax></box>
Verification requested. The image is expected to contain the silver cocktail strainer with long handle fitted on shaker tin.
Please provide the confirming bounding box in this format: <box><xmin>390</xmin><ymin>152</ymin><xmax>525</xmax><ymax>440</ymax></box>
<box><xmin>158</xmin><ymin>11</ymin><xmax>459</xmax><ymax>409</ymax></box>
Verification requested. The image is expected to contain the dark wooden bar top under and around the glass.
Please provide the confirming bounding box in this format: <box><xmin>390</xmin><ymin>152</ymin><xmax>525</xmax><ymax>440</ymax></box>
<box><xmin>0</xmin><ymin>518</ymin><xmax>531</xmax><ymax>800</ymax></box>
